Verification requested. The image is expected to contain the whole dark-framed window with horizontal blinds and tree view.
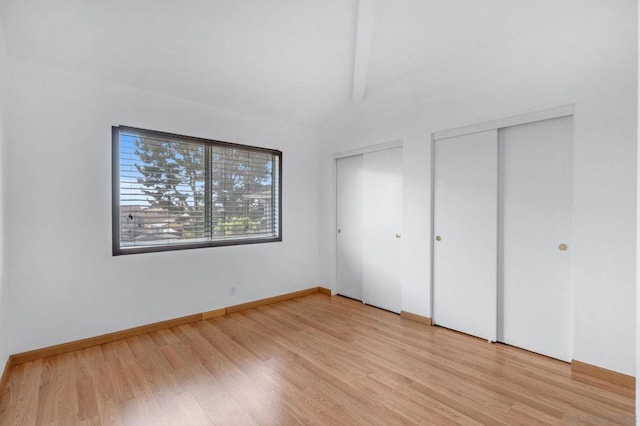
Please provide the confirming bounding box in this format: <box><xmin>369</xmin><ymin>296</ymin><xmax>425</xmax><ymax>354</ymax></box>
<box><xmin>112</xmin><ymin>126</ymin><xmax>282</xmax><ymax>255</ymax></box>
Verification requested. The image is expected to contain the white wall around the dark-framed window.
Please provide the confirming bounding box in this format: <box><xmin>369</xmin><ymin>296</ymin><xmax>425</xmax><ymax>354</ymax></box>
<box><xmin>0</xmin><ymin>59</ymin><xmax>320</xmax><ymax>355</ymax></box>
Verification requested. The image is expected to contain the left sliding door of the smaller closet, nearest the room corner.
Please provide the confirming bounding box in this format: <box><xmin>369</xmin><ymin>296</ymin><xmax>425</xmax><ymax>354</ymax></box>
<box><xmin>336</xmin><ymin>155</ymin><xmax>364</xmax><ymax>300</ymax></box>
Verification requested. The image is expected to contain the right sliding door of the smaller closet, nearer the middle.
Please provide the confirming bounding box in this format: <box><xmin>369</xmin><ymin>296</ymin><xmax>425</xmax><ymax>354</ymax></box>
<box><xmin>362</xmin><ymin>148</ymin><xmax>403</xmax><ymax>313</ymax></box>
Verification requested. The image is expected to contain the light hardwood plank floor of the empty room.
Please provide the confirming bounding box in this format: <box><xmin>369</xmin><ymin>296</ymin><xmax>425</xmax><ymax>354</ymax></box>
<box><xmin>0</xmin><ymin>294</ymin><xmax>634</xmax><ymax>425</ymax></box>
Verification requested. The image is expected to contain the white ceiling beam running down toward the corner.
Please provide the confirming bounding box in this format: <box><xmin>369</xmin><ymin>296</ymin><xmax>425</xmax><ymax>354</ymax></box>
<box><xmin>351</xmin><ymin>0</ymin><xmax>376</xmax><ymax>104</ymax></box>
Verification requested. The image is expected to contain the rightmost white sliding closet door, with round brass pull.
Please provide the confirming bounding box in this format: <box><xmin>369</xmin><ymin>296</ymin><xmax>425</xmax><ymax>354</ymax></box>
<box><xmin>500</xmin><ymin>117</ymin><xmax>572</xmax><ymax>361</ymax></box>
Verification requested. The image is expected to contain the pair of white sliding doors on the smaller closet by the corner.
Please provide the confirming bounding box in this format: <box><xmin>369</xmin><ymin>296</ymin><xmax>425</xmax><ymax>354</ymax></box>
<box><xmin>336</xmin><ymin>148</ymin><xmax>402</xmax><ymax>312</ymax></box>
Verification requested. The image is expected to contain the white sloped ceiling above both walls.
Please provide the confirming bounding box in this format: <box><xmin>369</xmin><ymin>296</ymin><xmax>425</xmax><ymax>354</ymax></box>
<box><xmin>0</xmin><ymin>0</ymin><xmax>624</xmax><ymax>128</ymax></box>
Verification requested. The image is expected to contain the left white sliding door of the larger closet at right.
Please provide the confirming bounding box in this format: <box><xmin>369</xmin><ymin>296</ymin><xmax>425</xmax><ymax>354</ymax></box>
<box><xmin>433</xmin><ymin>130</ymin><xmax>498</xmax><ymax>341</ymax></box>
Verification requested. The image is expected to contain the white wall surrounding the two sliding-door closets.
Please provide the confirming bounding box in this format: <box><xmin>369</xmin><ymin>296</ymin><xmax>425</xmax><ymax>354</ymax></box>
<box><xmin>321</xmin><ymin>1</ymin><xmax>638</xmax><ymax>375</ymax></box>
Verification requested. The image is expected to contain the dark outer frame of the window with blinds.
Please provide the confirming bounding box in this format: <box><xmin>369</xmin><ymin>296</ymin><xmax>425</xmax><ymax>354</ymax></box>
<box><xmin>111</xmin><ymin>125</ymin><xmax>282</xmax><ymax>256</ymax></box>
